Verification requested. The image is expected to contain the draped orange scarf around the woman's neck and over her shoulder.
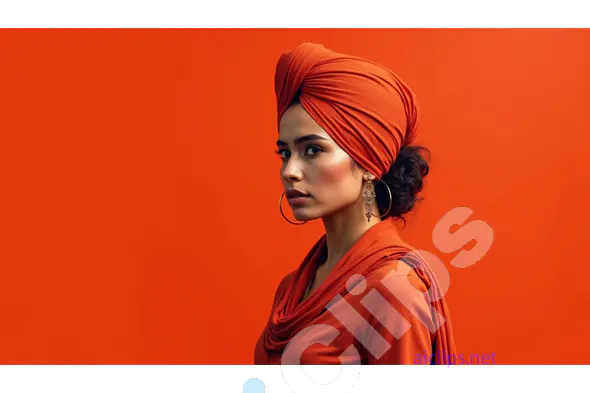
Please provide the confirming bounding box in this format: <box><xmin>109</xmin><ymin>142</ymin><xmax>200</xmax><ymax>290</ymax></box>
<box><xmin>261</xmin><ymin>218</ymin><xmax>456</xmax><ymax>364</ymax></box>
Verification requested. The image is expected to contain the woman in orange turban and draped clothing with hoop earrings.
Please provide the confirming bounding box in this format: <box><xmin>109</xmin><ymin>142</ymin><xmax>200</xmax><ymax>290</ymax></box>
<box><xmin>254</xmin><ymin>43</ymin><xmax>455</xmax><ymax>364</ymax></box>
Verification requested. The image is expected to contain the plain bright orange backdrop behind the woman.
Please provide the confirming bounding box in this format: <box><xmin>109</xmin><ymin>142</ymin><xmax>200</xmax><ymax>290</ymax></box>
<box><xmin>0</xmin><ymin>29</ymin><xmax>590</xmax><ymax>364</ymax></box>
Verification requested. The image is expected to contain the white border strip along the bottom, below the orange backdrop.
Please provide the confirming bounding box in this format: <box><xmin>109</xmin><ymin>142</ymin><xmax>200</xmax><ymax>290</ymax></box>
<box><xmin>0</xmin><ymin>366</ymin><xmax>590</xmax><ymax>393</ymax></box>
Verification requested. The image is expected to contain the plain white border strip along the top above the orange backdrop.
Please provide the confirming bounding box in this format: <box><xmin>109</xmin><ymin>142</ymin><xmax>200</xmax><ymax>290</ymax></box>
<box><xmin>0</xmin><ymin>0</ymin><xmax>590</xmax><ymax>28</ymax></box>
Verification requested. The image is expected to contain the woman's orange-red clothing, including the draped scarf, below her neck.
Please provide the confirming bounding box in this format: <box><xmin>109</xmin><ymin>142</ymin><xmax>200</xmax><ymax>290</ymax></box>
<box><xmin>254</xmin><ymin>218</ymin><xmax>456</xmax><ymax>364</ymax></box>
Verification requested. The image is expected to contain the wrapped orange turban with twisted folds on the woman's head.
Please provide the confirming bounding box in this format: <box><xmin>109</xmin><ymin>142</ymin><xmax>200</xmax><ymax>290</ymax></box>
<box><xmin>275</xmin><ymin>43</ymin><xmax>418</xmax><ymax>177</ymax></box>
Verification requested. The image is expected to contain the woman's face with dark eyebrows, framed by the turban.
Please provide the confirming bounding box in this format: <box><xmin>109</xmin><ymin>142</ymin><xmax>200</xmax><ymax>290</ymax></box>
<box><xmin>277</xmin><ymin>103</ymin><xmax>363</xmax><ymax>221</ymax></box>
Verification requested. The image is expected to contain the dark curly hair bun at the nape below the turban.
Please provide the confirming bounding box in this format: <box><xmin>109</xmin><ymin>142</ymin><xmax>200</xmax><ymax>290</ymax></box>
<box><xmin>375</xmin><ymin>145</ymin><xmax>430</xmax><ymax>227</ymax></box>
